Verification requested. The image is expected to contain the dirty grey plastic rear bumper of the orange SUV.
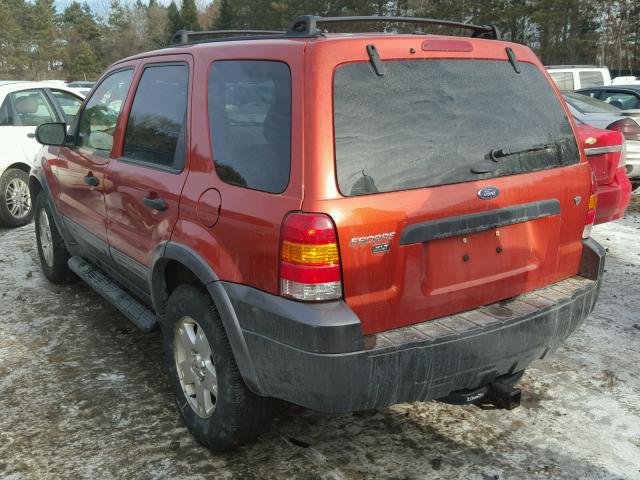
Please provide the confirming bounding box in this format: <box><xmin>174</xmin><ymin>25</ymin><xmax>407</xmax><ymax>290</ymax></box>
<box><xmin>224</xmin><ymin>240</ymin><xmax>605</xmax><ymax>412</ymax></box>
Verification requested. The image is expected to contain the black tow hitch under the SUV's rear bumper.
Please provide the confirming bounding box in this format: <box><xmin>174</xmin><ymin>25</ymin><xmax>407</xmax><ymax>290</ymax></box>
<box><xmin>439</xmin><ymin>371</ymin><xmax>524</xmax><ymax>410</ymax></box>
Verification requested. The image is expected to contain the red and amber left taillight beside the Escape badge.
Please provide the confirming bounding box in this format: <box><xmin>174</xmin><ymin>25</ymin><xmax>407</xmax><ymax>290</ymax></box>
<box><xmin>280</xmin><ymin>213</ymin><xmax>342</xmax><ymax>302</ymax></box>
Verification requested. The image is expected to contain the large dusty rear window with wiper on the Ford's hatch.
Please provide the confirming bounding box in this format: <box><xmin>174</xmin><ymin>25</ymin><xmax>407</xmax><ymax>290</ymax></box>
<box><xmin>334</xmin><ymin>60</ymin><xmax>580</xmax><ymax>196</ymax></box>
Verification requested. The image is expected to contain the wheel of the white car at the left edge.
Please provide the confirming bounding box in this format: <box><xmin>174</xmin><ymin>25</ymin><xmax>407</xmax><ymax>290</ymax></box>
<box><xmin>0</xmin><ymin>168</ymin><xmax>33</xmax><ymax>228</ymax></box>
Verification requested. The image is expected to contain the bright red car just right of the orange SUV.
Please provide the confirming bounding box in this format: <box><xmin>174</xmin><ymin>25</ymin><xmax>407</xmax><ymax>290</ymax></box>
<box><xmin>575</xmin><ymin>122</ymin><xmax>631</xmax><ymax>225</ymax></box>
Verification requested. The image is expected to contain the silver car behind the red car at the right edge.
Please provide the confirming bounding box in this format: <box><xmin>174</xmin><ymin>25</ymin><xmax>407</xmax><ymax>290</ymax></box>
<box><xmin>564</xmin><ymin>93</ymin><xmax>640</xmax><ymax>190</ymax></box>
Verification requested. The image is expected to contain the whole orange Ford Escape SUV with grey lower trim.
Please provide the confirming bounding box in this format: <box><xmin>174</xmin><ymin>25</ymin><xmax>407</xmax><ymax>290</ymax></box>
<box><xmin>30</xmin><ymin>16</ymin><xmax>604</xmax><ymax>450</ymax></box>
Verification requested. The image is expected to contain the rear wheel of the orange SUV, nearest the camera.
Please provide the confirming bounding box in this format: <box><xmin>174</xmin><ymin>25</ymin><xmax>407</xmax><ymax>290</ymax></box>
<box><xmin>162</xmin><ymin>285</ymin><xmax>272</xmax><ymax>452</ymax></box>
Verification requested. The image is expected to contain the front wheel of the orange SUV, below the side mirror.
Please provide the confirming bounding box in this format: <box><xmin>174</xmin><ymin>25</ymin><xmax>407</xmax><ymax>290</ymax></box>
<box><xmin>34</xmin><ymin>192</ymin><xmax>77</xmax><ymax>285</ymax></box>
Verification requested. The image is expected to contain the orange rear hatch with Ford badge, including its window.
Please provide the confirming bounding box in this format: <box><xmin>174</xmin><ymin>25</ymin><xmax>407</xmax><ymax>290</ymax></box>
<box><xmin>303</xmin><ymin>40</ymin><xmax>591</xmax><ymax>333</ymax></box>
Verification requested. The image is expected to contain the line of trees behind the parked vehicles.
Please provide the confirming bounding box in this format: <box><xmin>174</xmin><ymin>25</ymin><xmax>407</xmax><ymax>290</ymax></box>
<box><xmin>0</xmin><ymin>0</ymin><xmax>640</xmax><ymax>81</ymax></box>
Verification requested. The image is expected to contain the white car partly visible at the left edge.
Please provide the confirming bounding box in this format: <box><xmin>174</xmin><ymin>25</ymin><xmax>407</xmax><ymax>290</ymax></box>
<box><xmin>0</xmin><ymin>81</ymin><xmax>83</xmax><ymax>228</ymax></box>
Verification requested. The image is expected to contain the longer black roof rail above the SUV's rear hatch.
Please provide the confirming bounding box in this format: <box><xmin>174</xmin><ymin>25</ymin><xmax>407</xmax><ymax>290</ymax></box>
<box><xmin>286</xmin><ymin>15</ymin><xmax>500</xmax><ymax>40</ymax></box>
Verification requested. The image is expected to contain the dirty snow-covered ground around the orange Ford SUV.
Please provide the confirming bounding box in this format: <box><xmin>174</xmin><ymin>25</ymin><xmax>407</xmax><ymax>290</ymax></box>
<box><xmin>0</xmin><ymin>196</ymin><xmax>640</xmax><ymax>480</ymax></box>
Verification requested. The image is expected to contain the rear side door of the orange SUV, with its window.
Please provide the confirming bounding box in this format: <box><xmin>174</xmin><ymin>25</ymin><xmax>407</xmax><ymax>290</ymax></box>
<box><xmin>105</xmin><ymin>55</ymin><xmax>191</xmax><ymax>289</ymax></box>
